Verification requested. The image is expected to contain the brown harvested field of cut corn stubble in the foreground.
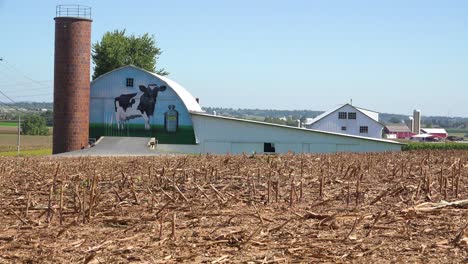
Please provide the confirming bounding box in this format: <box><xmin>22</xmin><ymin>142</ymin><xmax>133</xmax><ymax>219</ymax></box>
<box><xmin>0</xmin><ymin>151</ymin><xmax>468</xmax><ymax>263</ymax></box>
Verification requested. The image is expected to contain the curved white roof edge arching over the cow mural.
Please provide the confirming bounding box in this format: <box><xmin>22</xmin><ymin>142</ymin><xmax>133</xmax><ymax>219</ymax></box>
<box><xmin>91</xmin><ymin>65</ymin><xmax>203</xmax><ymax>112</ymax></box>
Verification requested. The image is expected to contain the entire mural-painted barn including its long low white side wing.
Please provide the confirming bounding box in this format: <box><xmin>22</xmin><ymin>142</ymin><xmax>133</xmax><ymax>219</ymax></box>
<box><xmin>89</xmin><ymin>66</ymin><xmax>401</xmax><ymax>154</ymax></box>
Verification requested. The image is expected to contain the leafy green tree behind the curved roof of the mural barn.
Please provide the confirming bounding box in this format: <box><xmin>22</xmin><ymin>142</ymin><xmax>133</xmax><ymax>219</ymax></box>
<box><xmin>92</xmin><ymin>30</ymin><xmax>169</xmax><ymax>79</ymax></box>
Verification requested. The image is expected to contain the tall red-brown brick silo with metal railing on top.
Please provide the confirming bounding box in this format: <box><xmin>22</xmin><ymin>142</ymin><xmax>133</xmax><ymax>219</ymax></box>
<box><xmin>53</xmin><ymin>5</ymin><xmax>92</xmax><ymax>154</ymax></box>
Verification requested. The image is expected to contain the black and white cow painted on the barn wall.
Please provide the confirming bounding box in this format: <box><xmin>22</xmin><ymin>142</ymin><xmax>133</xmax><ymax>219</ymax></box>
<box><xmin>114</xmin><ymin>84</ymin><xmax>166</xmax><ymax>130</ymax></box>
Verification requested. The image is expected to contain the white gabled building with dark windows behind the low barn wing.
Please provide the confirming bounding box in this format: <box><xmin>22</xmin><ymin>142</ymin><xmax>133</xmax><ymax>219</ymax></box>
<box><xmin>304</xmin><ymin>104</ymin><xmax>384</xmax><ymax>139</ymax></box>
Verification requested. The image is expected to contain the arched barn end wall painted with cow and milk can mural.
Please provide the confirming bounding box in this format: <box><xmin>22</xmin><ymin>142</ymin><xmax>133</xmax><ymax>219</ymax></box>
<box><xmin>89</xmin><ymin>66</ymin><xmax>196</xmax><ymax>144</ymax></box>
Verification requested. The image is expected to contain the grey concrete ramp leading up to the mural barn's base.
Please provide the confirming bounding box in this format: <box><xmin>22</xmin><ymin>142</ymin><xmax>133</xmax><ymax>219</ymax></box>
<box><xmin>54</xmin><ymin>137</ymin><xmax>170</xmax><ymax>157</ymax></box>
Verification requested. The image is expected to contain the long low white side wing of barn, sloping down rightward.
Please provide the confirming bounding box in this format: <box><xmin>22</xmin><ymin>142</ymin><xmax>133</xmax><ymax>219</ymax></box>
<box><xmin>158</xmin><ymin>114</ymin><xmax>401</xmax><ymax>154</ymax></box>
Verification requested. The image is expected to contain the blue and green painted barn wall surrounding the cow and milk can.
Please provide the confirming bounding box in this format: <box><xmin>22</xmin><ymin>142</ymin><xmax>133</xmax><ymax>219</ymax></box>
<box><xmin>89</xmin><ymin>66</ymin><xmax>196</xmax><ymax>144</ymax></box>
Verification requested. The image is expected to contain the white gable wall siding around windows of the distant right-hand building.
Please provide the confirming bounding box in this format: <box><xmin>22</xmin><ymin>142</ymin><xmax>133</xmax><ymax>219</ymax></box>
<box><xmin>309</xmin><ymin>105</ymin><xmax>383</xmax><ymax>138</ymax></box>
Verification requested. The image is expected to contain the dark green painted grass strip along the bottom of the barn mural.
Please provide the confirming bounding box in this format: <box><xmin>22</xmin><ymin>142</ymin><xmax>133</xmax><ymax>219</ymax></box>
<box><xmin>89</xmin><ymin>123</ymin><xmax>195</xmax><ymax>144</ymax></box>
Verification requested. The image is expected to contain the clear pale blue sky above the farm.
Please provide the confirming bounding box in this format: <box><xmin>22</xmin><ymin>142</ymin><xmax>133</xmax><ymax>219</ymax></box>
<box><xmin>0</xmin><ymin>0</ymin><xmax>468</xmax><ymax>117</ymax></box>
